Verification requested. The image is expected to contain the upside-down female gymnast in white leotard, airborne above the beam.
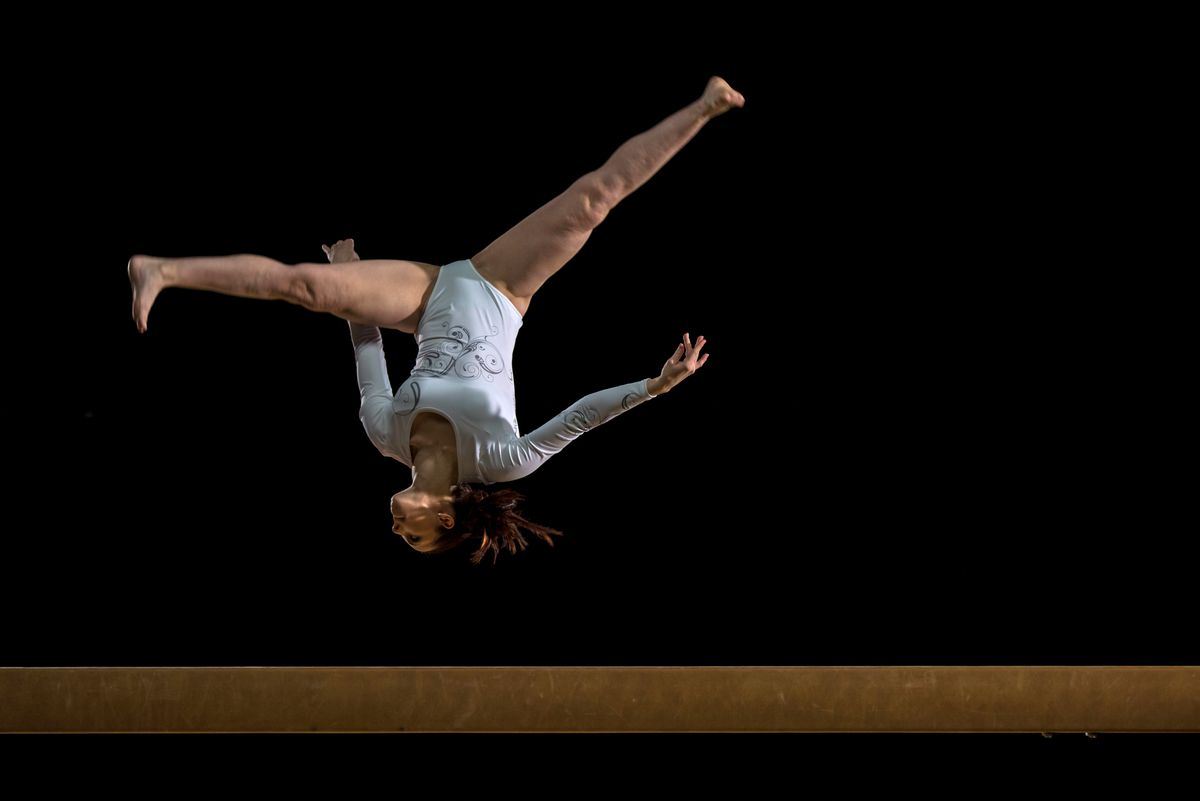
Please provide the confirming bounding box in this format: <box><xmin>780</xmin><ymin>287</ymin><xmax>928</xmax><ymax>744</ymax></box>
<box><xmin>128</xmin><ymin>77</ymin><xmax>745</xmax><ymax>564</ymax></box>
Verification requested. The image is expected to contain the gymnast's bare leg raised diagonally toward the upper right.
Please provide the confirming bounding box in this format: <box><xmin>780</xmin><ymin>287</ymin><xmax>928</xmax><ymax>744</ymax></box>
<box><xmin>472</xmin><ymin>78</ymin><xmax>745</xmax><ymax>314</ymax></box>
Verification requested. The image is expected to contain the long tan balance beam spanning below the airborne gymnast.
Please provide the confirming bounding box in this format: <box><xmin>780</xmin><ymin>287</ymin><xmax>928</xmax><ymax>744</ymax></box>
<box><xmin>0</xmin><ymin>666</ymin><xmax>1200</xmax><ymax>733</ymax></box>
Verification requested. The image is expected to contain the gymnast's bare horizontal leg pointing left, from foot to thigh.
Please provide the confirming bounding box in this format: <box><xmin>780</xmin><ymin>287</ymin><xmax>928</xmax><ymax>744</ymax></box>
<box><xmin>128</xmin><ymin>254</ymin><xmax>438</xmax><ymax>333</ymax></box>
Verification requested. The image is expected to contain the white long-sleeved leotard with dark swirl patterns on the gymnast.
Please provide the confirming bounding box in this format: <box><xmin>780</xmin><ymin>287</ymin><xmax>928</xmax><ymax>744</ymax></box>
<box><xmin>350</xmin><ymin>259</ymin><xmax>654</xmax><ymax>484</ymax></box>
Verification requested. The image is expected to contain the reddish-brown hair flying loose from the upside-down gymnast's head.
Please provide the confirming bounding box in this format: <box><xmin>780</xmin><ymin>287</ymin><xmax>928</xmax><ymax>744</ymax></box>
<box><xmin>428</xmin><ymin>483</ymin><xmax>563</xmax><ymax>565</ymax></box>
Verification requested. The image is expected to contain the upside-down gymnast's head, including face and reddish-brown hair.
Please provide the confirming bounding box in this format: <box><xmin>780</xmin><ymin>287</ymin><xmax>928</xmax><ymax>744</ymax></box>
<box><xmin>391</xmin><ymin>484</ymin><xmax>563</xmax><ymax>565</ymax></box>
